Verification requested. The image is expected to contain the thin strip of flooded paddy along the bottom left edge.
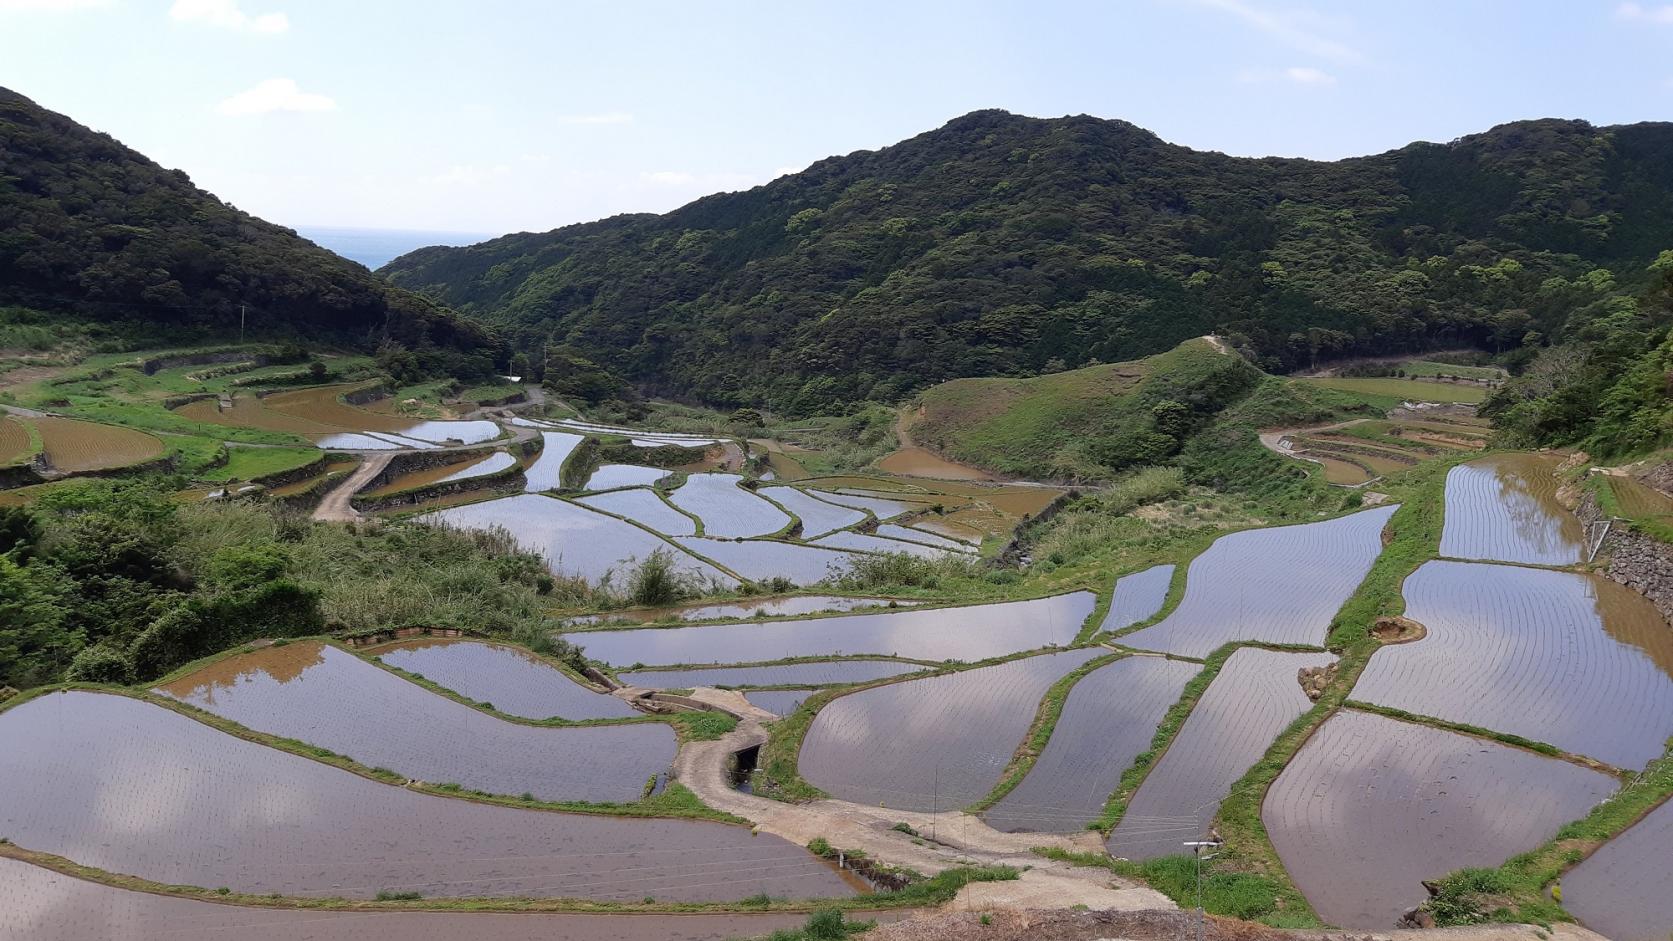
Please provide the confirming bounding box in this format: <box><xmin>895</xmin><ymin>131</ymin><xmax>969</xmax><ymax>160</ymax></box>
<box><xmin>0</xmin><ymin>857</ymin><xmax>806</xmax><ymax>941</ymax></box>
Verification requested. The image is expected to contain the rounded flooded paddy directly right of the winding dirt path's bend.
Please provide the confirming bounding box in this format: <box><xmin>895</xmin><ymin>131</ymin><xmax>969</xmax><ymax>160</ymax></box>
<box><xmin>800</xmin><ymin>650</ymin><xmax>1099</xmax><ymax>810</ymax></box>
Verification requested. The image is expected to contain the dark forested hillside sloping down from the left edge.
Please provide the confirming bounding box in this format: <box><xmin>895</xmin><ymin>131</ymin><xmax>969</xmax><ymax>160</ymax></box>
<box><xmin>0</xmin><ymin>89</ymin><xmax>492</xmax><ymax>372</ymax></box>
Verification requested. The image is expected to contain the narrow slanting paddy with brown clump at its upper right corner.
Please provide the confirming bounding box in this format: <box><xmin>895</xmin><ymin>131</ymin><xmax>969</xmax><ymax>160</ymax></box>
<box><xmin>1108</xmin><ymin>648</ymin><xmax>1335</xmax><ymax>859</ymax></box>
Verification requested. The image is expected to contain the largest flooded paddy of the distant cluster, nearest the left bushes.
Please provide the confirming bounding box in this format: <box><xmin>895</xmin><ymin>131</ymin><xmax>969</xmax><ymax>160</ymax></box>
<box><xmin>420</xmin><ymin>494</ymin><xmax>736</xmax><ymax>586</ymax></box>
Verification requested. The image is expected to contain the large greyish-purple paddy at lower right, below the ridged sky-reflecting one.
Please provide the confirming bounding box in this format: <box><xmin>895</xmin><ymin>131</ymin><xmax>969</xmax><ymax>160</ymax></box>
<box><xmin>1261</xmin><ymin>710</ymin><xmax>1618</xmax><ymax>929</ymax></box>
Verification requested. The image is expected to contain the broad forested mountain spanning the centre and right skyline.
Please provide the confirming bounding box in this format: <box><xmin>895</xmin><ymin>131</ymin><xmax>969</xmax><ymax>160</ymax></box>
<box><xmin>381</xmin><ymin>111</ymin><xmax>1673</xmax><ymax>412</ymax></box>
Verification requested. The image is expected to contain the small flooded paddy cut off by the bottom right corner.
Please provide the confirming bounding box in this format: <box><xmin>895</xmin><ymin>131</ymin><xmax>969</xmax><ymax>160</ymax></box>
<box><xmin>1563</xmin><ymin>790</ymin><xmax>1673</xmax><ymax>941</ymax></box>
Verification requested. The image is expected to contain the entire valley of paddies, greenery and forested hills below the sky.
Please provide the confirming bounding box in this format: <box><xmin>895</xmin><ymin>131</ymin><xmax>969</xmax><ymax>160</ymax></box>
<box><xmin>0</xmin><ymin>82</ymin><xmax>1673</xmax><ymax>941</ymax></box>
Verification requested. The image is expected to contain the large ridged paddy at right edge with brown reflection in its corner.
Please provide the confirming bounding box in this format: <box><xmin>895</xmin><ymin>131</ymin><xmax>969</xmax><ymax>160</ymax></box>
<box><xmin>1353</xmin><ymin>561</ymin><xmax>1673</xmax><ymax>769</ymax></box>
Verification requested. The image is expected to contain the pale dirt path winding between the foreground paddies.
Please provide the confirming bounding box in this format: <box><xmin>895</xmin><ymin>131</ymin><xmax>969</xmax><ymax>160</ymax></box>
<box><xmin>674</xmin><ymin>717</ymin><xmax>1176</xmax><ymax>911</ymax></box>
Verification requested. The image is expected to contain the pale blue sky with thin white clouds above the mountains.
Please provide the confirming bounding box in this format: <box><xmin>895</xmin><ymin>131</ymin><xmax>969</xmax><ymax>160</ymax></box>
<box><xmin>0</xmin><ymin>0</ymin><xmax>1673</xmax><ymax>233</ymax></box>
